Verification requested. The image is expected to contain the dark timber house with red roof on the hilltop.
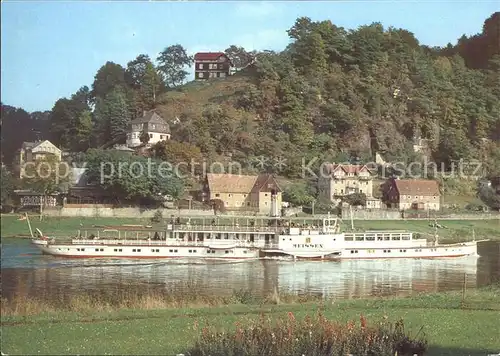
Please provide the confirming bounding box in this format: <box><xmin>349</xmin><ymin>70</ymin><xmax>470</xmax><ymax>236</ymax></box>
<box><xmin>194</xmin><ymin>52</ymin><xmax>233</xmax><ymax>80</ymax></box>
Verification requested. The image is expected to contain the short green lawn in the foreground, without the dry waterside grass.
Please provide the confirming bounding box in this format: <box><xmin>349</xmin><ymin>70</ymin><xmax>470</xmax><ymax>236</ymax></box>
<box><xmin>2</xmin><ymin>286</ymin><xmax>500</xmax><ymax>356</ymax></box>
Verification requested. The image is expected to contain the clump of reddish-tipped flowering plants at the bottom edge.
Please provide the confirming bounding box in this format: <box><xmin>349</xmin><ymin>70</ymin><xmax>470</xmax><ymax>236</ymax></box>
<box><xmin>186</xmin><ymin>312</ymin><xmax>427</xmax><ymax>356</ymax></box>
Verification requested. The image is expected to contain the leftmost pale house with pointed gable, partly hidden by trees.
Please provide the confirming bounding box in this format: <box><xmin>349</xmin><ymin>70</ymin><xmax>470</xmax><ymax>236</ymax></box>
<box><xmin>14</xmin><ymin>140</ymin><xmax>62</xmax><ymax>178</ymax></box>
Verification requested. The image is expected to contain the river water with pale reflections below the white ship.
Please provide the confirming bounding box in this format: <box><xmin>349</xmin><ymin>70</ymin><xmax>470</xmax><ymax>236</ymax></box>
<box><xmin>1</xmin><ymin>239</ymin><xmax>500</xmax><ymax>300</ymax></box>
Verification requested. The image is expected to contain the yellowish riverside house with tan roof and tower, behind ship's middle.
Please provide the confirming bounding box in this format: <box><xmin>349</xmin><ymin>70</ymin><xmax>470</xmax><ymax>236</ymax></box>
<box><xmin>202</xmin><ymin>173</ymin><xmax>282</xmax><ymax>216</ymax></box>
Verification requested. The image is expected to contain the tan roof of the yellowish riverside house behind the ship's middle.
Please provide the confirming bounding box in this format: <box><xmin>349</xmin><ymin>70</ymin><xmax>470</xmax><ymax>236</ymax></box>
<box><xmin>207</xmin><ymin>173</ymin><xmax>281</xmax><ymax>193</ymax></box>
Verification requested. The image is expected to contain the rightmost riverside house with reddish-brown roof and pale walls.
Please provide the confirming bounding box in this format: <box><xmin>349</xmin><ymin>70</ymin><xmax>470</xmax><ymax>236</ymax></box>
<box><xmin>383</xmin><ymin>178</ymin><xmax>441</xmax><ymax>210</ymax></box>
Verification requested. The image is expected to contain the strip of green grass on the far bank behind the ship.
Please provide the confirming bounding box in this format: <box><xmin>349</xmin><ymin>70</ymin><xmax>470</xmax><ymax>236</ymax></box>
<box><xmin>1</xmin><ymin>215</ymin><xmax>500</xmax><ymax>242</ymax></box>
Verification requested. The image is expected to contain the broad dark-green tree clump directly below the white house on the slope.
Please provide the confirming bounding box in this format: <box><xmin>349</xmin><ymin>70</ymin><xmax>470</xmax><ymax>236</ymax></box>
<box><xmin>86</xmin><ymin>149</ymin><xmax>184</xmax><ymax>204</ymax></box>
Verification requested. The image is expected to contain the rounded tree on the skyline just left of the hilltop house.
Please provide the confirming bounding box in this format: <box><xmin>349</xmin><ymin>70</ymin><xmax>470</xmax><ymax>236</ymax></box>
<box><xmin>157</xmin><ymin>44</ymin><xmax>193</xmax><ymax>88</ymax></box>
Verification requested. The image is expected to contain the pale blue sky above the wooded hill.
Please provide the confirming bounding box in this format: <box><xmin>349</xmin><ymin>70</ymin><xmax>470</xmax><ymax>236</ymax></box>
<box><xmin>0</xmin><ymin>0</ymin><xmax>500</xmax><ymax>111</ymax></box>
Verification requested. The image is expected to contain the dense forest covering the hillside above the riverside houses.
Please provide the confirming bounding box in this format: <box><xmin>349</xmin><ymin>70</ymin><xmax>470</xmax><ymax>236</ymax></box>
<box><xmin>2</xmin><ymin>12</ymin><xmax>500</xmax><ymax>178</ymax></box>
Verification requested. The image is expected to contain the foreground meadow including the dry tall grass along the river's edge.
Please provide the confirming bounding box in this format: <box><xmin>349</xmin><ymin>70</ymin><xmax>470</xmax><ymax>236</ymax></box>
<box><xmin>2</xmin><ymin>285</ymin><xmax>500</xmax><ymax>356</ymax></box>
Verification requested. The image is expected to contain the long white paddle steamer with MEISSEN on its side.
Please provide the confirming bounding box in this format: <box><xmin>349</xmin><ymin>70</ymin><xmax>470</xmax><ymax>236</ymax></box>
<box><xmin>28</xmin><ymin>217</ymin><xmax>484</xmax><ymax>260</ymax></box>
